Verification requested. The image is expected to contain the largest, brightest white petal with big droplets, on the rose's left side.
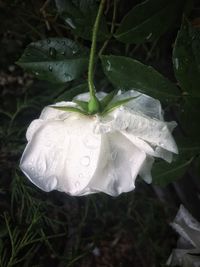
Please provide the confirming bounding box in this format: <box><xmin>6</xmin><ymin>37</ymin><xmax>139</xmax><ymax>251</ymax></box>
<box><xmin>21</xmin><ymin>116</ymin><xmax>101</xmax><ymax>195</ymax></box>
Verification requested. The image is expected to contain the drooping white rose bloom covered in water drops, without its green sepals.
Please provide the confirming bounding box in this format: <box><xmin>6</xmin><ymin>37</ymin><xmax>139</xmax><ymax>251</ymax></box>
<box><xmin>20</xmin><ymin>90</ymin><xmax>178</xmax><ymax>196</ymax></box>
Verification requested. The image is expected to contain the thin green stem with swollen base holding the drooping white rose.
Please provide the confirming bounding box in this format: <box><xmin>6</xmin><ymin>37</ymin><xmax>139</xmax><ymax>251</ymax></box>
<box><xmin>88</xmin><ymin>0</ymin><xmax>106</xmax><ymax>113</ymax></box>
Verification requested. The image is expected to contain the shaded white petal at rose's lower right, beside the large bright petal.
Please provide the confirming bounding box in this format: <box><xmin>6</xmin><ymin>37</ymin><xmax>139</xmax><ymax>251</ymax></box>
<box><xmin>88</xmin><ymin>133</ymin><xmax>146</xmax><ymax>196</ymax></box>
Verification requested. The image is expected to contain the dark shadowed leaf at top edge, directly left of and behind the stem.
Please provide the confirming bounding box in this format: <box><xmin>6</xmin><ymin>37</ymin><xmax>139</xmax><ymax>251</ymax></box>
<box><xmin>56</xmin><ymin>0</ymin><xmax>109</xmax><ymax>41</ymax></box>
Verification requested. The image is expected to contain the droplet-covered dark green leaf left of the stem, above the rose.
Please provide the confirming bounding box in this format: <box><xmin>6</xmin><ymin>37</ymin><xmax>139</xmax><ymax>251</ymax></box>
<box><xmin>17</xmin><ymin>38</ymin><xmax>88</xmax><ymax>83</ymax></box>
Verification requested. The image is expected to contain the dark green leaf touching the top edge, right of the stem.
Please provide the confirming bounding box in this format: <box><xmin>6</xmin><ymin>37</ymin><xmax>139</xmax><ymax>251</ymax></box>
<box><xmin>115</xmin><ymin>0</ymin><xmax>185</xmax><ymax>44</ymax></box>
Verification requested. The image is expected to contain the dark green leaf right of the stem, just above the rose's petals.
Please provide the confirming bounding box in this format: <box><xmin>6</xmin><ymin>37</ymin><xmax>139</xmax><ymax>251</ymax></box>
<box><xmin>101</xmin><ymin>56</ymin><xmax>179</xmax><ymax>101</ymax></box>
